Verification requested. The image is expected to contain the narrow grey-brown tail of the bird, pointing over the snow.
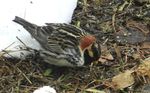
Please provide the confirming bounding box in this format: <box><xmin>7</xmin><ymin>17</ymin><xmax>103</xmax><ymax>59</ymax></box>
<box><xmin>13</xmin><ymin>16</ymin><xmax>38</xmax><ymax>36</ymax></box>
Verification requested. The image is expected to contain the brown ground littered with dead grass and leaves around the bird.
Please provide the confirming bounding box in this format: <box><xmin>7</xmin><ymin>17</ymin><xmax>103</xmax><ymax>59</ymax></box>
<box><xmin>0</xmin><ymin>0</ymin><xmax>150</xmax><ymax>93</ymax></box>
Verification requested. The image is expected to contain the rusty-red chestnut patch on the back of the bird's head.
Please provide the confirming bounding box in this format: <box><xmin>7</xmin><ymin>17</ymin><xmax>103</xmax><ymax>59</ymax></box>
<box><xmin>80</xmin><ymin>35</ymin><xmax>96</xmax><ymax>50</ymax></box>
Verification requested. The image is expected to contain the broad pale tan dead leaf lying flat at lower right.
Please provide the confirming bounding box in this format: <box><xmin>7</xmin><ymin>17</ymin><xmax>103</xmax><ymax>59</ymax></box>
<box><xmin>112</xmin><ymin>70</ymin><xmax>135</xmax><ymax>89</ymax></box>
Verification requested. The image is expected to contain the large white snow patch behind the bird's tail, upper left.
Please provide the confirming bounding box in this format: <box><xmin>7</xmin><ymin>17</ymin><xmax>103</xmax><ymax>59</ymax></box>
<box><xmin>0</xmin><ymin>0</ymin><xmax>77</xmax><ymax>57</ymax></box>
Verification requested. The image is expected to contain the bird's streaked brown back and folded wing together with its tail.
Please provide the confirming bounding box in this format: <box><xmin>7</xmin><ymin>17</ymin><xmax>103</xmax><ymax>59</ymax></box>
<box><xmin>13</xmin><ymin>16</ymin><xmax>82</xmax><ymax>58</ymax></box>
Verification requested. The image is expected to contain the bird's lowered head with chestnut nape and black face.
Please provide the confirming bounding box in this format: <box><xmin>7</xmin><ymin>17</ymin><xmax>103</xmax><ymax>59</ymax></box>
<box><xmin>80</xmin><ymin>35</ymin><xmax>101</xmax><ymax>65</ymax></box>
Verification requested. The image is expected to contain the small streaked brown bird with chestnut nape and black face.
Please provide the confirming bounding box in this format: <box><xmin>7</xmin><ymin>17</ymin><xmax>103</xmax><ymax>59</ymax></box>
<box><xmin>13</xmin><ymin>16</ymin><xmax>101</xmax><ymax>67</ymax></box>
